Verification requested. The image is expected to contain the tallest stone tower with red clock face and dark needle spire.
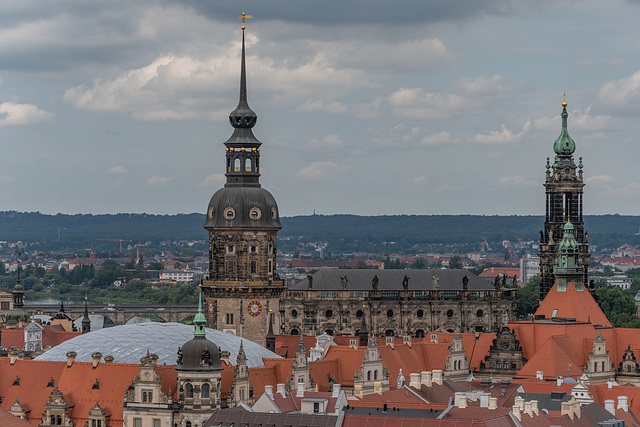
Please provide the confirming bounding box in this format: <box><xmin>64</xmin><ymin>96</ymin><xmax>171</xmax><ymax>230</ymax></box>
<box><xmin>203</xmin><ymin>25</ymin><xmax>285</xmax><ymax>345</ymax></box>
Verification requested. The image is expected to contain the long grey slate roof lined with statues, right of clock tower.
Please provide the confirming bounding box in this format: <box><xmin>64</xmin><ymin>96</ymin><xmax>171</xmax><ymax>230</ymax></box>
<box><xmin>289</xmin><ymin>269</ymin><xmax>494</xmax><ymax>291</ymax></box>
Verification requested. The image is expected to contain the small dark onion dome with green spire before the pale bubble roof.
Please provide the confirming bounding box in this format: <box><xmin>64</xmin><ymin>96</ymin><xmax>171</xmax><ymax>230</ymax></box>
<box><xmin>176</xmin><ymin>292</ymin><xmax>222</xmax><ymax>371</ymax></box>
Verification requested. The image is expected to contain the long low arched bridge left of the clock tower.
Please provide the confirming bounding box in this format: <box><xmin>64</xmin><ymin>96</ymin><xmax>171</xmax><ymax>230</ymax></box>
<box><xmin>25</xmin><ymin>304</ymin><xmax>198</xmax><ymax>325</ymax></box>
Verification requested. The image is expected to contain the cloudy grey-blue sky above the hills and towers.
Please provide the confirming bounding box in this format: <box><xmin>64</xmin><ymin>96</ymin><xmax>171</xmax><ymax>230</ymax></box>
<box><xmin>0</xmin><ymin>0</ymin><xmax>640</xmax><ymax>216</ymax></box>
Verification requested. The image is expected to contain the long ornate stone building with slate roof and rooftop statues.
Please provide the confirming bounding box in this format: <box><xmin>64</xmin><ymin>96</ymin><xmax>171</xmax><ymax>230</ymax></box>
<box><xmin>280</xmin><ymin>270</ymin><xmax>516</xmax><ymax>337</ymax></box>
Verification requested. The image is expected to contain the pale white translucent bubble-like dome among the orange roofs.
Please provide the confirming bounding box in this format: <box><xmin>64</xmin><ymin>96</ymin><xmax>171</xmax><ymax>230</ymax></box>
<box><xmin>35</xmin><ymin>322</ymin><xmax>280</xmax><ymax>368</ymax></box>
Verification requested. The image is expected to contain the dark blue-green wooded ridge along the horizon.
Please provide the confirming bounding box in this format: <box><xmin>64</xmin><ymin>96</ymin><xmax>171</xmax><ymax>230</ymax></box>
<box><xmin>0</xmin><ymin>212</ymin><xmax>640</xmax><ymax>252</ymax></box>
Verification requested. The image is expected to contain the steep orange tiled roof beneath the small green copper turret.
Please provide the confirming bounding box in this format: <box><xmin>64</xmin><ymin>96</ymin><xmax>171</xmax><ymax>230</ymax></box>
<box><xmin>535</xmin><ymin>282</ymin><xmax>612</xmax><ymax>328</ymax></box>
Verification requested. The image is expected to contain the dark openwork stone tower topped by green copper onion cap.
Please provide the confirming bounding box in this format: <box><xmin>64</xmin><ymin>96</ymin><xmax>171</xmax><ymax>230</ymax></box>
<box><xmin>540</xmin><ymin>102</ymin><xmax>592</xmax><ymax>300</ymax></box>
